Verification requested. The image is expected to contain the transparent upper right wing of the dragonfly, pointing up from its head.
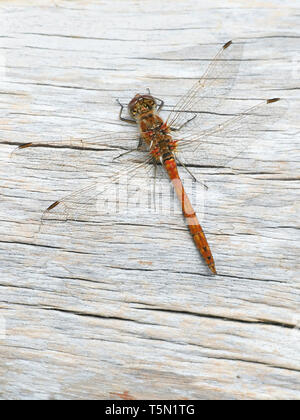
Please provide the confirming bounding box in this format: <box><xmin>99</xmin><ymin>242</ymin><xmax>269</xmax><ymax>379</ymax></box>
<box><xmin>167</xmin><ymin>41</ymin><xmax>243</xmax><ymax>129</ymax></box>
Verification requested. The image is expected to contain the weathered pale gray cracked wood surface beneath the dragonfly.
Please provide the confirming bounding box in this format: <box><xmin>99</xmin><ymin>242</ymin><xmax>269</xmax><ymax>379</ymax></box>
<box><xmin>0</xmin><ymin>0</ymin><xmax>300</xmax><ymax>399</ymax></box>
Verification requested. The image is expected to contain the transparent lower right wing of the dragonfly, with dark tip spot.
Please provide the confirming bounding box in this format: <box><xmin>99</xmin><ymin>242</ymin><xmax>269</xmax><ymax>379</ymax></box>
<box><xmin>178</xmin><ymin>98</ymin><xmax>287</xmax><ymax>167</ymax></box>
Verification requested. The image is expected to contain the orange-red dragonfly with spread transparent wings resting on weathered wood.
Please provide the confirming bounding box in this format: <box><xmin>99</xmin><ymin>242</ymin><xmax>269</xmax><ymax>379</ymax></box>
<box><xmin>17</xmin><ymin>41</ymin><xmax>282</xmax><ymax>275</ymax></box>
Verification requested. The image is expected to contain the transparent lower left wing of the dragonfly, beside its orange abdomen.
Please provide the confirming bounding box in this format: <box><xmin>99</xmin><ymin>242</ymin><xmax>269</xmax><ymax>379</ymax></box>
<box><xmin>37</xmin><ymin>150</ymin><xmax>204</xmax><ymax>240</ymax></box>
